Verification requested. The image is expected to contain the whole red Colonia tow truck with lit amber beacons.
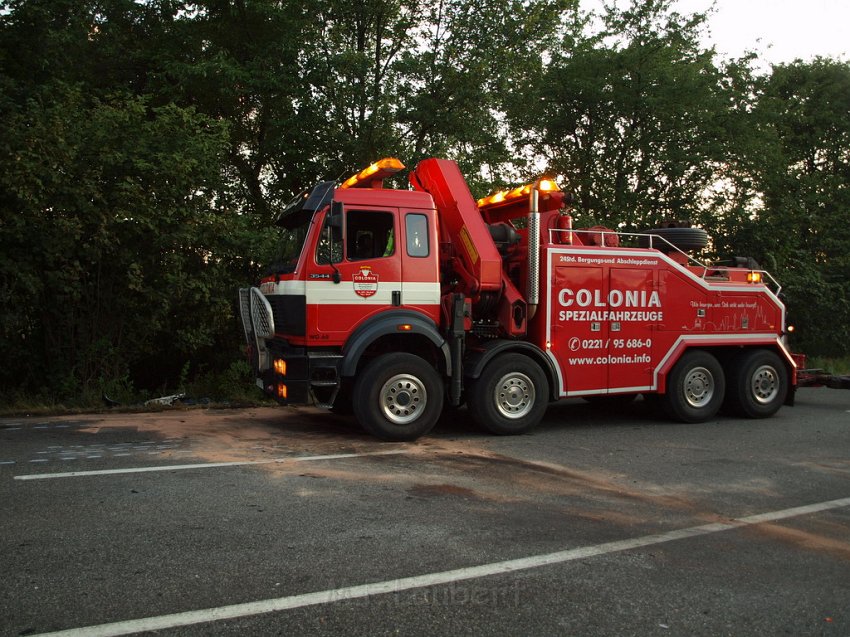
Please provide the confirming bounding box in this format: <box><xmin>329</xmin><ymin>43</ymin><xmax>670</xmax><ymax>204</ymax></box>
<box><xmin>239</xmin><ymin>158</ymin><xmax>797</xmax><ymax>441</ymax></box>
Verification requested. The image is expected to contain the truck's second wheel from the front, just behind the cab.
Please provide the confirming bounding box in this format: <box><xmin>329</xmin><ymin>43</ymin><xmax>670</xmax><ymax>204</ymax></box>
<box><xmin>467</xmin><ymin>354</ymin><xmax>549</xmax><ymax>435</ymax></box>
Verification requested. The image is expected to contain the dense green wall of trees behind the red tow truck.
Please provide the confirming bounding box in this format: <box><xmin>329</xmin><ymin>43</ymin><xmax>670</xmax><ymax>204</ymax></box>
<box><xmin>0</xmin><ymin>0</ymin><xmax>850</xmax><ymax>400</ymax></box>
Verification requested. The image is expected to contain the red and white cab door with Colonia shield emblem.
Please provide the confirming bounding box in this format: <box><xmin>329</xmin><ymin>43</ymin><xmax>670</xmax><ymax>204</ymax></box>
<box><xmin>307</xmin><ymin>207</ymin><xmax>401</xmax><ymax>344</ymax></box>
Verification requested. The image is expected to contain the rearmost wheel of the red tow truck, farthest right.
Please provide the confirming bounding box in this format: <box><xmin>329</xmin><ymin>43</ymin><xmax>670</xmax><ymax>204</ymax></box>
<box><xmin>726</xmin><ymin>349</ymin><xmax>788</xmax><ymax>418</ymax></box>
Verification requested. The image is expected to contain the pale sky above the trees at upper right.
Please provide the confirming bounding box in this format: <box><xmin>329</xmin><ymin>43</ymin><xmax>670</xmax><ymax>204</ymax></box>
<box><xmin>581</xmin><ymin>0</ymin><xmax>850</xmax><ymax>66</ymax></box>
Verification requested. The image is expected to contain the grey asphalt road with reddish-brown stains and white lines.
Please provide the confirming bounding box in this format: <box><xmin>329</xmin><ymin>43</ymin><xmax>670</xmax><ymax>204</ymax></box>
<box><xmin>0</xmin><ymin>389</ymin><xmax>850</xmax><ymax>636</ymax></box>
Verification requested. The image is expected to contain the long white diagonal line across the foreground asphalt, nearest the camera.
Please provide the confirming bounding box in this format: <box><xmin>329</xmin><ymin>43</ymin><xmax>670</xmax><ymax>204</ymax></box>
<box><xmin>26</xmin><ymin>498</ymin><xmax>850</xmax><ymax>637</ymax></box>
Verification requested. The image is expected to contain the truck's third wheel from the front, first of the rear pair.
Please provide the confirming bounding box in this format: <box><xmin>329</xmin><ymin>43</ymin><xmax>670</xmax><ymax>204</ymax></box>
<box><xmin>662</xmin><ymin>350</ymin><xmax>726</xmax><ymax>422</ymax></box>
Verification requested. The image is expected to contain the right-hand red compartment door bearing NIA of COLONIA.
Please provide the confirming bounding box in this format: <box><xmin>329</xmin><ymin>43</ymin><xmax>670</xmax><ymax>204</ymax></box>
<box><xmin>607</xmin><ymin>268</ymin><xmax>661</xmax><ymax>391</ymax></box>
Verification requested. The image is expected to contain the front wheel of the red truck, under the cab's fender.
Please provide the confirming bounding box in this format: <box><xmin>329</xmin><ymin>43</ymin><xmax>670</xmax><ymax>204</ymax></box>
<box><xmin>353</xmin><ymin>352</ymin><xmax>443</xmax><ymax>442</ymax></box>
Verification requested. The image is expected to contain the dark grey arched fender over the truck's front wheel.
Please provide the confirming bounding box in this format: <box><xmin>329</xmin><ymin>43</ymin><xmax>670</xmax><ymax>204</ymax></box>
<box><xmin>340</xmin><ymin>310</ymin><xmax>452</xmax><ymax>376</ymax></box>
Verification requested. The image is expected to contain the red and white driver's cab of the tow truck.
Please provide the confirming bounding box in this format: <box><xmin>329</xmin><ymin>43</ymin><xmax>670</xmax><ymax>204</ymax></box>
<box><xmin>240</xmin><ymin>160</ymin><xmax>446</xmax><ymax>428</ymax></box>
